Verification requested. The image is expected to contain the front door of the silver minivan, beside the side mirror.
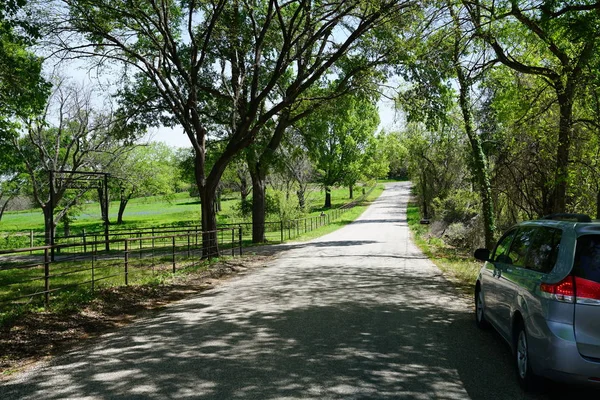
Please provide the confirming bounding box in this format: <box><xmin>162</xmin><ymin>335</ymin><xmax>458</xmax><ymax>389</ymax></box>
<box><xmin>481</xmin><ymin>229</ymin><xmax>517</xmax><ymax>325</ymax></box>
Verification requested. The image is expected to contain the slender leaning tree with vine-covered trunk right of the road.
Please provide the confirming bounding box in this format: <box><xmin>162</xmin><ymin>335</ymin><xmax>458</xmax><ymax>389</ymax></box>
<box><xmin>401</xmin><ymin>1</ymin><xmax>496</xmax><ymax>248</ymax></box>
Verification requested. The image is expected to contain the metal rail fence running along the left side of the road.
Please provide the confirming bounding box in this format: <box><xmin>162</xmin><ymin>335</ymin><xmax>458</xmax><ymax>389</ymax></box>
<box><xmin>0</xmin><ymin>187</ymin><xmax>374</xmax><ymax>312</ymax></box>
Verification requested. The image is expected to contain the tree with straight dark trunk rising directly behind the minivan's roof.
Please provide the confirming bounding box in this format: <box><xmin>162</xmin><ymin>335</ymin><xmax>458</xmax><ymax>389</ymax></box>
<box><xmin>463</xmin><ymin>0</ymin><xmax>600</xmax><ymax>213</ymax></box>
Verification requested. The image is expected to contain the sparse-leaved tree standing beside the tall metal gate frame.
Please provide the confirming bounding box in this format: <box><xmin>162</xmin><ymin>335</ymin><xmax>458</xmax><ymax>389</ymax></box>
<box><xmin>13</xmin><ymin>80</ymin><xmax>135</xmax><ymax>244</ymax></box>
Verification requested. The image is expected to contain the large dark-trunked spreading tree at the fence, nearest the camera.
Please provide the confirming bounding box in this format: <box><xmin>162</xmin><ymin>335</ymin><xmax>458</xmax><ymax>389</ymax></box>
<box><xmin>53</xmin><ymin>0</ymin><xmax>413</xmax><ymax>256</ymax></box>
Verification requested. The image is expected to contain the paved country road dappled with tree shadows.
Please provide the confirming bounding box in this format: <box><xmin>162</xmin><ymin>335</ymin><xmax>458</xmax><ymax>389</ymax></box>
<box><xmin>0</xmin><ymin>183</ymin><xmax>598</xmax><ymax>400</ymax></box>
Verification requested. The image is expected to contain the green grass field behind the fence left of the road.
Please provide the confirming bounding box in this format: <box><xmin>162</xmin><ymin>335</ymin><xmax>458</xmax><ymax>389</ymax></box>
<box><xmin>0</xmin><ymin>185</ymin><xmax>383</xmax><ymax>325</ymax></box>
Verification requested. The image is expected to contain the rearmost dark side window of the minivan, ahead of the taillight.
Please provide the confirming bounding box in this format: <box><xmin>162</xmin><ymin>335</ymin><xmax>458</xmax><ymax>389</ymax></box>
<box><xmin>525</xmin><ymin>226</ymin><xmax>562</xmax><ymax>273</ymax></box>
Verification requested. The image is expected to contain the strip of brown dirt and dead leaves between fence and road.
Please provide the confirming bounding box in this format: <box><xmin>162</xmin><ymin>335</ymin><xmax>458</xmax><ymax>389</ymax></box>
<box><xmin>0</xmin><ymin>255</ymin><xmax>272</xmax><ymax>380</ymax></box>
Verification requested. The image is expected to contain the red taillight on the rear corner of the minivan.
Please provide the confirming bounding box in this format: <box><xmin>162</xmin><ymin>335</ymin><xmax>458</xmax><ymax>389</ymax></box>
<box><xmin>540</xmin><ymin>275</ymin><xmax>600</xmax><ymax>304</ymax></box>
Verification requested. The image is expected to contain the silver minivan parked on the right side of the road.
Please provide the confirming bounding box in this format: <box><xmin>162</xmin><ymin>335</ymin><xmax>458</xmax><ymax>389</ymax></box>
<box><xmin>475</xmin><ymin>214</ymin><xmax>600</xmax><ymax>389</ymax></box>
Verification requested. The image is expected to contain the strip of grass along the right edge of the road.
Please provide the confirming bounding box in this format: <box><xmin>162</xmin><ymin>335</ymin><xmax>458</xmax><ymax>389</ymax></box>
<box><xmin>407</xmin><ymin>203</ymin><xmax>481</xmax><ymax>295</ymax></box>
